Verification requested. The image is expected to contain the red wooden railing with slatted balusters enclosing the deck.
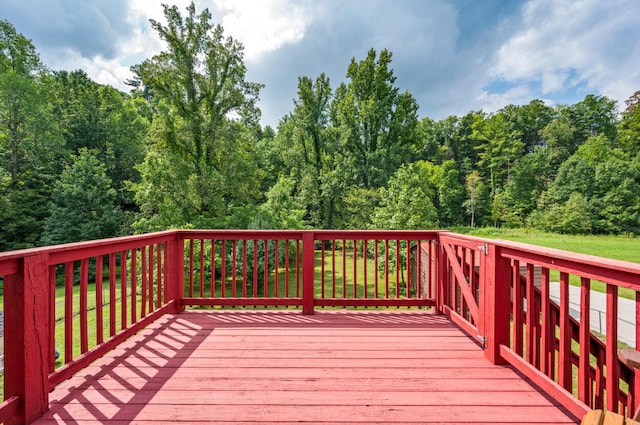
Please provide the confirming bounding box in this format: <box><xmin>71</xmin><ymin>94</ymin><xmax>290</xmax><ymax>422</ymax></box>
<box><xmin>0</xmin><ymin>230</ymin><xmax>640</xmax><ymax>424</ymax></box>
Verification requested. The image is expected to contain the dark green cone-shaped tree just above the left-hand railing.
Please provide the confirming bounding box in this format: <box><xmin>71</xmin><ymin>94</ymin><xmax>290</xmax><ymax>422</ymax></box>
<box><xmin>42</xmin><ymin>149</ymin><xmax>123</xmax><ymax>245</ymax></box>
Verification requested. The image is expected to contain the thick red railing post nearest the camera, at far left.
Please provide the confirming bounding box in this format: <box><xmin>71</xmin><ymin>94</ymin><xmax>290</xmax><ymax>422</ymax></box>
<box><xmin>4</xmin><ymin>254</ymin><xmax>53</xmax><ymax>425</ymax></box>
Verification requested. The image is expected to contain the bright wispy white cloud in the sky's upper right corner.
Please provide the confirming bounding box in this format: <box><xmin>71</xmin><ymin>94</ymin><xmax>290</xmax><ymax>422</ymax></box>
<box><xmin>492</xmin><ymin>0</ymin><xmax>640</xmax><ymax>101</ymax></box>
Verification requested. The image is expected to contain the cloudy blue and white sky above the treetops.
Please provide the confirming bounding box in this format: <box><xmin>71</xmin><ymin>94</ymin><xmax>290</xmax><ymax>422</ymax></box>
<box><xmin>0</xmin><ymin>0</ymin><xmax>640</xmax><ymax>128</ymax></box>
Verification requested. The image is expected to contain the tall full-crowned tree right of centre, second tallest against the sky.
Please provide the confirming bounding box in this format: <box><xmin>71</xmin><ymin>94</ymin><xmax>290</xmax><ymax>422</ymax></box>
<box><xmin>332</xmin><ymin>49</ymin><xmax>418</xmax><ymax>188</ymax></box>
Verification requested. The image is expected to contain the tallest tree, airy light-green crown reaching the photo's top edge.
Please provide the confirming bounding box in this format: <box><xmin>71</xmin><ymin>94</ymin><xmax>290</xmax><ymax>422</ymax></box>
<box><xmin>132</xmin><ymin>3</ymin><xmax>261</xmax><ymax>230</ymax></box>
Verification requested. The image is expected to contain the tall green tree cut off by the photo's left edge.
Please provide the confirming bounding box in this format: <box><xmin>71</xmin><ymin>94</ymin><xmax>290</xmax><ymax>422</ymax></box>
<box><xmin>0</xmin><ymin>20</ymin><xmax>63</xmax><ymax>250</ymax></box>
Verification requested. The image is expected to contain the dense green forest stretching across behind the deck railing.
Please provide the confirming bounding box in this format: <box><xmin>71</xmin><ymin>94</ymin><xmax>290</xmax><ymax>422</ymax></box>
<box><xmin>0</xmin><ymin>4</ymin><xmax>640</xmax><ymax>251</ymax></box>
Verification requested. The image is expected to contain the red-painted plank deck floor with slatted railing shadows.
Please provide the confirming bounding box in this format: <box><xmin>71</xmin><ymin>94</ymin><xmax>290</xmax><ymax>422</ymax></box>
<box><xmin>35</xmin><ymin>310</ymin><xmax>579</xmax><ymax>425</ymax></box>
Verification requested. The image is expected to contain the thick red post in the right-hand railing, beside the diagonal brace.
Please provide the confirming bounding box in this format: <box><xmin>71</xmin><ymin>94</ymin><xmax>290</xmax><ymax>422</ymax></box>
<box><xmin>478</xmin><ymin>243</ymin><xmax>511</xmax><ymax>364</ymax></box>
